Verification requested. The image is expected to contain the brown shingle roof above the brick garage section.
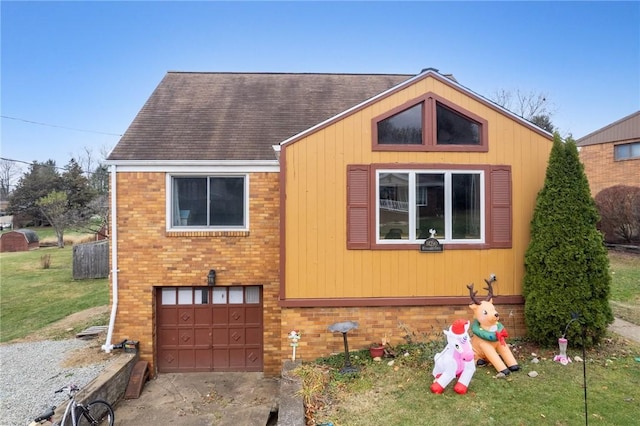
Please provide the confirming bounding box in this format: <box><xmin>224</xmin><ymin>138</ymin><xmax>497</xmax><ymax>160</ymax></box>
<box><xmin>108</xmin><ymin>72</ymin><xmax>413</xmax><ymax>161</ymax></box>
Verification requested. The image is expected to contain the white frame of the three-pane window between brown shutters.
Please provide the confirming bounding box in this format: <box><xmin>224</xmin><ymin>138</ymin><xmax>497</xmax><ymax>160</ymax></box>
<box><xmin>375</xmin><ymin>169</ymin><xmax>486</xmax><ymax>245</ymax></box>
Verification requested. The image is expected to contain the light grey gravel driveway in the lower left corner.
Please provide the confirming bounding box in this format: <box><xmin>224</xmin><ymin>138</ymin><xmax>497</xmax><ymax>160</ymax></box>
<box><xmin>0</xmin><ymin>339</ymin><xmax>108</xmax><ymax>426</ymax></box>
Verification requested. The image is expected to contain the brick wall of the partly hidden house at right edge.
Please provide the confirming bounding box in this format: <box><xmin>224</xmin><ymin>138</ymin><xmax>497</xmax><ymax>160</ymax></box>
<box><xmin>580</xmin><ymin>143</ymin><xmax>640</xmax><ymax>198</ymax></box>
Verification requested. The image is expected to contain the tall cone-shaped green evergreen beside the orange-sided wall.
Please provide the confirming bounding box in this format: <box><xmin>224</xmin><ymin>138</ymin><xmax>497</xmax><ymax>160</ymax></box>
<box><xmin>523</xmin><ymin>133</ymin><xmax>613</xmax><ymax>346</ymax></box>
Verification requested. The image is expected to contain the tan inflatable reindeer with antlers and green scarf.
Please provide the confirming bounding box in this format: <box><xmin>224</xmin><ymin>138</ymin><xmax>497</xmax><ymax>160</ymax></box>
<box><xmin>467</xmin><ymin>276</ymin><xmax>520</xmax><ymax>375</ymax></box>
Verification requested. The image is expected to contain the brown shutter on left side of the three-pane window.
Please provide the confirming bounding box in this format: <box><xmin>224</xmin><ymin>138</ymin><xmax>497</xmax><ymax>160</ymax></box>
<box><xmin>347</xmin><ymin>164</ymin><xmax>370</xmax><ymax>249</ymax></box>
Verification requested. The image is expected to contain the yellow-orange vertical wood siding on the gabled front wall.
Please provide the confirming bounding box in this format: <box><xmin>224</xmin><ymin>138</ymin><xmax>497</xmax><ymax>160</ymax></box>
<box><xmin>283</xmin><ymin>78</ymin><xmax>551</xmax><ymax>299</ymax></box>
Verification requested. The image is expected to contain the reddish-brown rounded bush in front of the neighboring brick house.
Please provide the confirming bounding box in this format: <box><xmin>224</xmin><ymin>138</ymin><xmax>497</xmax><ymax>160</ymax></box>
<box><xmin>596</xmin><ymin>185</ymin><xmax>640</xmax><ymax>243</ymax></box>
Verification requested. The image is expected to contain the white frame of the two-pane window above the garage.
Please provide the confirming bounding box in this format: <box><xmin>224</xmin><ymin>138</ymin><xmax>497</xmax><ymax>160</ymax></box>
<box><xmin>165</xmin><ymin>173</ymin><xmax>250</xmax><ymax>232</ymax></box>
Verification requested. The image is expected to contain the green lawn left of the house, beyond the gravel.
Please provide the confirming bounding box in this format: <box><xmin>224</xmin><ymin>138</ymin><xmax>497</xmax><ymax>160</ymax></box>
<box><xmin>0</xmin><ymin>228</ymin><xmax>109</xmax><ymax>342</ymax></box>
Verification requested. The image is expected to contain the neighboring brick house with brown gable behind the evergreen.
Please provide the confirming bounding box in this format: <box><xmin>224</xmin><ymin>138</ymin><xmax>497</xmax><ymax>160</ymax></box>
<box><xmin>576</xmin><ymin>111</ymin><xmax>640</xmax><ymax>197</ymax></box>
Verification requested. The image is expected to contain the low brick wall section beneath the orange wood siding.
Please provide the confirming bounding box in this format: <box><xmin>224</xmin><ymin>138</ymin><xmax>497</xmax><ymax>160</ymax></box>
<box><xmin>280</xmin><ymin>305</ymin><xmax>526</xmax><ymax>361</ymax></box>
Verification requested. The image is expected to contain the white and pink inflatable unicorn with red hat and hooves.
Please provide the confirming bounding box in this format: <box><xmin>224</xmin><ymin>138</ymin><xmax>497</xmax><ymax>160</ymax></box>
<box><xmin>431</xmin><ymin>319</ymin><xmax>476</xmax><ymax>394</ymax></box>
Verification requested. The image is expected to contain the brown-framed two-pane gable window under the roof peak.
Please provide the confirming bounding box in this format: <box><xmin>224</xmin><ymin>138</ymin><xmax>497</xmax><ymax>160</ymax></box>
<box><xmin>372</xmin><ymin>93</ymin><xmax>488</xmax><ymax>151</ymax></box>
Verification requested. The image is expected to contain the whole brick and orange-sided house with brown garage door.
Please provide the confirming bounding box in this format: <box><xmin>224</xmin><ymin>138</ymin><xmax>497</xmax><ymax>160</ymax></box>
<box><xmin>105</xmin><ymin>69</ymin><xmax>552</xmax><ymax>375</ymax></box>
